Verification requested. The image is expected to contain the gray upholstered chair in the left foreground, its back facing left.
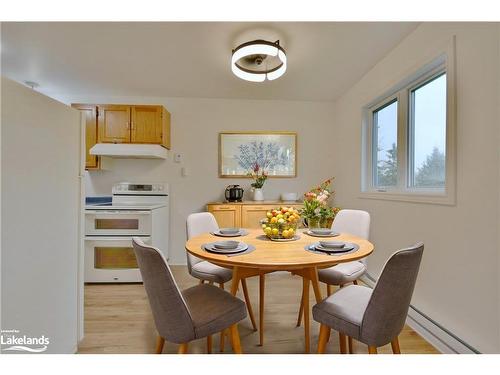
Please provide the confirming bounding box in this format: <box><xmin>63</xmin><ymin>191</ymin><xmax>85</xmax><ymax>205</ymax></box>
<box><xmin>132</xmin><ymin>237</ymin><xmax>247</xmax><ymax>354</ymax></box>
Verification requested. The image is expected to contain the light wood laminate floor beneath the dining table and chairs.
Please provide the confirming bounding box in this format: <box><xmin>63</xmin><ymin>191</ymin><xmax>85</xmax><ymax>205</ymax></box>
<box><xmin>78</xmin><ymin>266</ymin><xmax>437</xmax><ymax>354</ymax></box>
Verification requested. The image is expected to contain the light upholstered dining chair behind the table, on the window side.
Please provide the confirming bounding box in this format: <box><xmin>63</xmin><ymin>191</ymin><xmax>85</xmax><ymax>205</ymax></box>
<box><xmin>297</xmin><ymin>209</ymin><xmax>370</xmax><ymax>352</ymax></box>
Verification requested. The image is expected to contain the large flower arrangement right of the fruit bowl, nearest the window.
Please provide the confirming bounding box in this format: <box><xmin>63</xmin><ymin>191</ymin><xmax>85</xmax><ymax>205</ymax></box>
<box><xmin>301</xmin><ymin>177</ymin><xmax>340</xmax><ymax>227</ymax></box>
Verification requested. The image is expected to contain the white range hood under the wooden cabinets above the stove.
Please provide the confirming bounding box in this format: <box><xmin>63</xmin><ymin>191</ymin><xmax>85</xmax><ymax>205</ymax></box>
<box><xmin>89</xmin><ymin>143</ymin><xmax>167</xmax><ymax>159</ymax></box>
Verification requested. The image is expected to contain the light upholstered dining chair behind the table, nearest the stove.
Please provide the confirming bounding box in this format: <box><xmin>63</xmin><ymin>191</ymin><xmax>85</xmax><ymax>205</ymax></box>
<box><xmin>186</xmin><ymin>212</ymin><xmax>257</xmax><ymax>351</ymax></box>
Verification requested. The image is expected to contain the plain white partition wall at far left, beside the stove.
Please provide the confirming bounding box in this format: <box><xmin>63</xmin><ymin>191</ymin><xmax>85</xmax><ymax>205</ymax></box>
<box><xmin>1</xmin><ymin>78</ymin><xmax>80</xmax><ymax>353</ymax></box>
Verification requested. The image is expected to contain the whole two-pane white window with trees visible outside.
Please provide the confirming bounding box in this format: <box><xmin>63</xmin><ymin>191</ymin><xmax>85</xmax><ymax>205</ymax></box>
<box><xmin>362</xmin><ymin>51</ymin><xmax>455</xmax><ymax>204</ymax></box>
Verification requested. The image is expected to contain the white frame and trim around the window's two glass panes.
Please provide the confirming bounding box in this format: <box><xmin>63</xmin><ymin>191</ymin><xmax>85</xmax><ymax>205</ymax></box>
<box><xmin>360</xmin><ymin>38</ymin><xmax>456</xmax><ymax>205</ymax></box>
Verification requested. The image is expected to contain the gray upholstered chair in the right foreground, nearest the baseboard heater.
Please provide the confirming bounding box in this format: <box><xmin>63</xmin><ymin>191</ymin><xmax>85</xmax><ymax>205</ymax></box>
<box><xmin>313</xmin><ymin>243</ymin><xmax>424</xmax><ymax>354</ymax></box>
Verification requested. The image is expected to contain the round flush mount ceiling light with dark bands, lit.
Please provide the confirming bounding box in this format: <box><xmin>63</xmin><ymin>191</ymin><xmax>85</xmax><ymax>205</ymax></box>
<box><xmin>231</xmin><ymin>39</ymin><xmax>286</xmax><ymax>82</ymax></box>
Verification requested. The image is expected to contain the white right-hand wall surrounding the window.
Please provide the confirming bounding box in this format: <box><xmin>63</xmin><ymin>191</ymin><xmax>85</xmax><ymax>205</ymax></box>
<box><xmin>331</xmin><ymin>23</ymin><xmax>500</xmax><ymax>352</ymax></box>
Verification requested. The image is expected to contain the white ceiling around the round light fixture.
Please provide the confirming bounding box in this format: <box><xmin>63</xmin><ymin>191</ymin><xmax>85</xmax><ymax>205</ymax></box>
<box><xmin>1</xmin><ymin>22</ymin><xmax>418</xmax><ymax>101</ymax></box>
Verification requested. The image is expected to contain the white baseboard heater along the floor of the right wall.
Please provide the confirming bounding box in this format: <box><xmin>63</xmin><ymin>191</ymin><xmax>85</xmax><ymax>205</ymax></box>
<box><xmin>361</xmin><ymin>273</ymin><xmax>480</xmax><ymax>354</ymax></box>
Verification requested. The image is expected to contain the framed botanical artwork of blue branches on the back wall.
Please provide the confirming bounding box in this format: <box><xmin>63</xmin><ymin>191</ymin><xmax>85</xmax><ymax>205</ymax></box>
<box><xmin>219</xmin><ymin>132</ymin><xmax>297</xmax><ymax>178</ymax></box>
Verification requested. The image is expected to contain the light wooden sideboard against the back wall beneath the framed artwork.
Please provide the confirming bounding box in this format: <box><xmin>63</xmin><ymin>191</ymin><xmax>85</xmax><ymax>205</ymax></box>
<box><xmin>207</xmin><ymin>201</ymin><xmax>302</xmax><ymax>228</ymax></box>
